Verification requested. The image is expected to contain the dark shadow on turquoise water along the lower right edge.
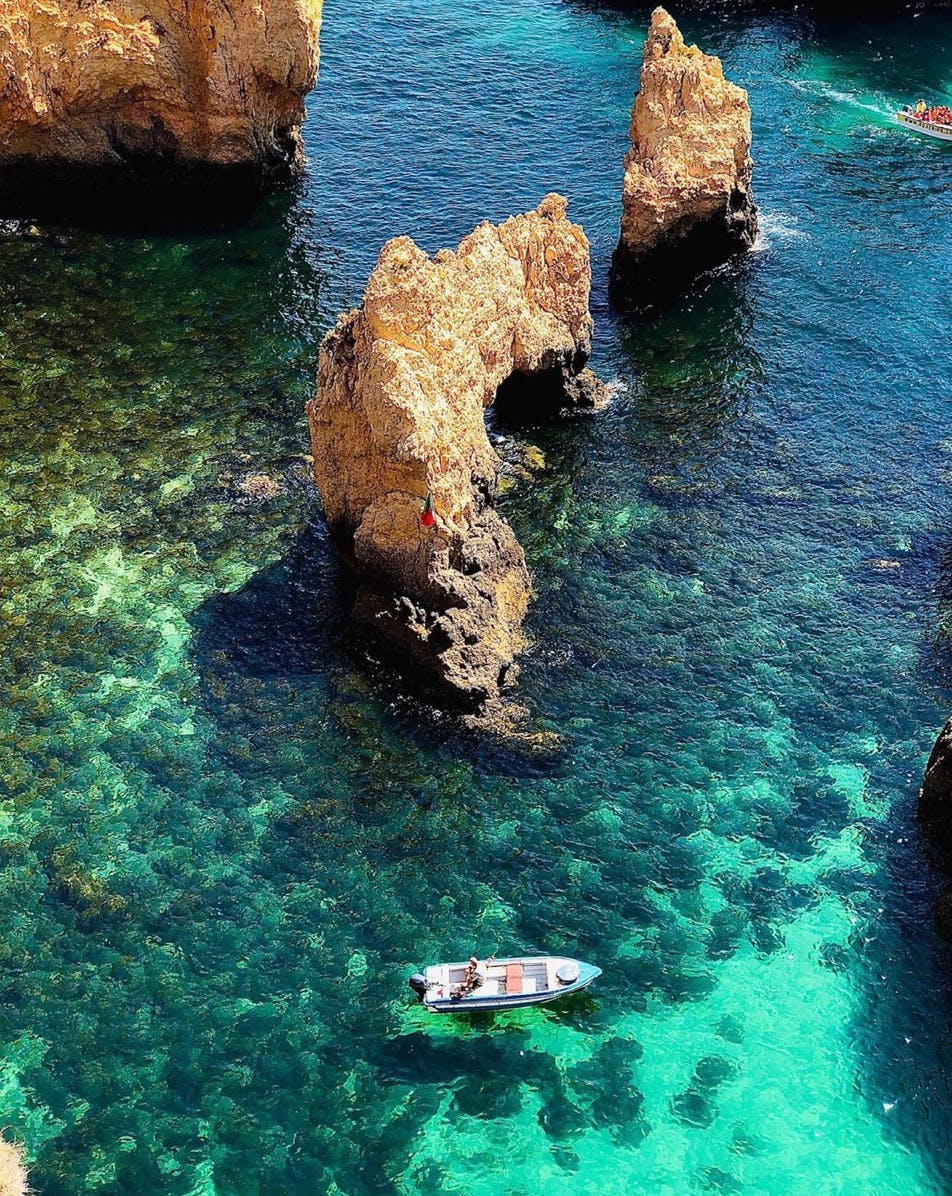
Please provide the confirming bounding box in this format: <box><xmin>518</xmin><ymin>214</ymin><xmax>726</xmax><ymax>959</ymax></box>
<box><xmin>841</xmin><ymin>536</ymin><xmax>952</xmax><ymax>1191</ymax></box>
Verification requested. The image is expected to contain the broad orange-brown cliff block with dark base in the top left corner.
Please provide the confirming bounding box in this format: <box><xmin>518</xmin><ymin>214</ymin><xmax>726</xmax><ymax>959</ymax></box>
<box><xmin>0</xmin><ymin>0</ymin><xmax>322</xmax><ymax>221</ymax></box>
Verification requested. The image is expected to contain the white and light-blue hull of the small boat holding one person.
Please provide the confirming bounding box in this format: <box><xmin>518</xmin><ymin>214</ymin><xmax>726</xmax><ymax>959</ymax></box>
<box><xmin>422</xmin><ymin>956</ymin><xmax>602</xmax><ymax>1013</ymax></box>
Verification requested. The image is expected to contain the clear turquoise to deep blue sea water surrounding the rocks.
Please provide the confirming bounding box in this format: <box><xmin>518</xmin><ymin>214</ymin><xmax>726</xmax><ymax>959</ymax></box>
<box><xmin>0</xmin><ymin>0</ymin><xmax>952</xmax><ymax>1196</ymax></box>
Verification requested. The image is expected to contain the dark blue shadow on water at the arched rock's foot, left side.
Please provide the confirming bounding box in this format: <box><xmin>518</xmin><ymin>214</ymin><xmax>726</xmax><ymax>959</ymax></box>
<box><xmin>185</xmin><ymin>517</ymin><xmax>568</xmax><ymax>777</ymax></box>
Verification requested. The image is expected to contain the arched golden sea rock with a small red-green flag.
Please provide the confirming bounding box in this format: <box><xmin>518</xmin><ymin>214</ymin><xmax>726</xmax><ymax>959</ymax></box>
<box><xmin>307</xmin><ymin>195</ymin><xmax>599</xmax><ymax>712</ymax></box>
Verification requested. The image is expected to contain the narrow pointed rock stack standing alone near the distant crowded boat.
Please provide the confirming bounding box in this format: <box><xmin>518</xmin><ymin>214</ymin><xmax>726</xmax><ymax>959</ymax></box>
<box><xmin>612</xmin><ymin>8</ymin><xmax>757</xmax><ymax>304</ymax></box>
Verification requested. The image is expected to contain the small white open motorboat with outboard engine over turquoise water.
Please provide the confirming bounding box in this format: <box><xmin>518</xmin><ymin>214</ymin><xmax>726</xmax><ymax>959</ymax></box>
<box><xmin>410</xmin><ymin>956</ymin><xmax>602</xmax><ymax>1013</ymax></box>
